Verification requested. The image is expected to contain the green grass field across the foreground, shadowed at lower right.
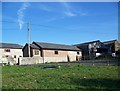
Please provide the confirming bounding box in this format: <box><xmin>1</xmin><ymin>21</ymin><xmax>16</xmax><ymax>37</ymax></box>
<box><xmin>2</xmin><ymin>65</ymin><xmax>120</xmax><ymax>91</ymax></box>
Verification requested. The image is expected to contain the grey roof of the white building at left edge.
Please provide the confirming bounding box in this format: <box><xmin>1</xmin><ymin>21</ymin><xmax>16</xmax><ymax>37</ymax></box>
<box><xmin>0</xmin><ymin>43</ymin><xmax>23</xmax><ymax>49</ymax></box>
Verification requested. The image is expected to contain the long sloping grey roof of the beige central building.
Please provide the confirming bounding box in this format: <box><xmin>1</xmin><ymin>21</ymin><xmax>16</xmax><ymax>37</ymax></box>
<box><xmin>33</xmin><ymin>42</ymin><xmax>80</xmax><ymax>51</ymax></box>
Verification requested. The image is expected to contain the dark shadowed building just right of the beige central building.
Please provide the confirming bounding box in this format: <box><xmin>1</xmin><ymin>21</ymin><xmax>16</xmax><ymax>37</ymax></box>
<box><xmin>74</xmin><ymin>40</ymin><xmax>108</xmax><ymax>60</ymax></box>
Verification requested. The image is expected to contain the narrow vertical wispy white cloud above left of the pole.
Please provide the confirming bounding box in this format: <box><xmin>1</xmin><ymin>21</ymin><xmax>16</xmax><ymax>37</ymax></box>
<box><xmin>17</xmin><ymin>2</ymin><xmax>30</xmax><ymax>30</ymax></box>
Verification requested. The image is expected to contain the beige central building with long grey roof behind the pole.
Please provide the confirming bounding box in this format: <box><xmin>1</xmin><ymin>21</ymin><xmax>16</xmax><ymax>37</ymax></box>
<box><xmin>22</xmin><ymin>42</ymin><xmax>82</xmax><ymax>63</ymax></box>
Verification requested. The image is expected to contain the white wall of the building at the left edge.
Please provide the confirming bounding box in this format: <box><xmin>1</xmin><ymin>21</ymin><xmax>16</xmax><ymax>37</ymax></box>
<box><xmin>0</xmin><ymin>48</ymin><xmax>23</xmax><ymax>63</ymax></box>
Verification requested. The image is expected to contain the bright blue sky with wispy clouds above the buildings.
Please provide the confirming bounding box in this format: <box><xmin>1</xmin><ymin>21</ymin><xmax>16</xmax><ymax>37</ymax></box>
<box><xmin>2</xmin><ymin>2</ymin><xmax>118</xmax><ymax>45</ymax></box>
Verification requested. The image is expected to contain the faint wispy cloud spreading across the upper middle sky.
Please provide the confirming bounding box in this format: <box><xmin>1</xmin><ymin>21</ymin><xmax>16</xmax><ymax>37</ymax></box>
<box><xmin>37</xmin><ymin>1</ymin><xmax>88</xmax><ymax>22</ymax></box>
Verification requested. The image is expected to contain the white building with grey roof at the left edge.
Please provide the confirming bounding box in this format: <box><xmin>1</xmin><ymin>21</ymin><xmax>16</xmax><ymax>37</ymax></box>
<box><xmin>0</xmin><ymin>43</ymin><xmax>23</xmax><ymax>64</ymax></box>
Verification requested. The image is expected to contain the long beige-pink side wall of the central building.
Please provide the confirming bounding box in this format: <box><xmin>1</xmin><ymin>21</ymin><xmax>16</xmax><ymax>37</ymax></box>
<box><xmin>43</xmin><ymin>50</ymin><xmax>82</xmax><ymax>62</ymax></box>
